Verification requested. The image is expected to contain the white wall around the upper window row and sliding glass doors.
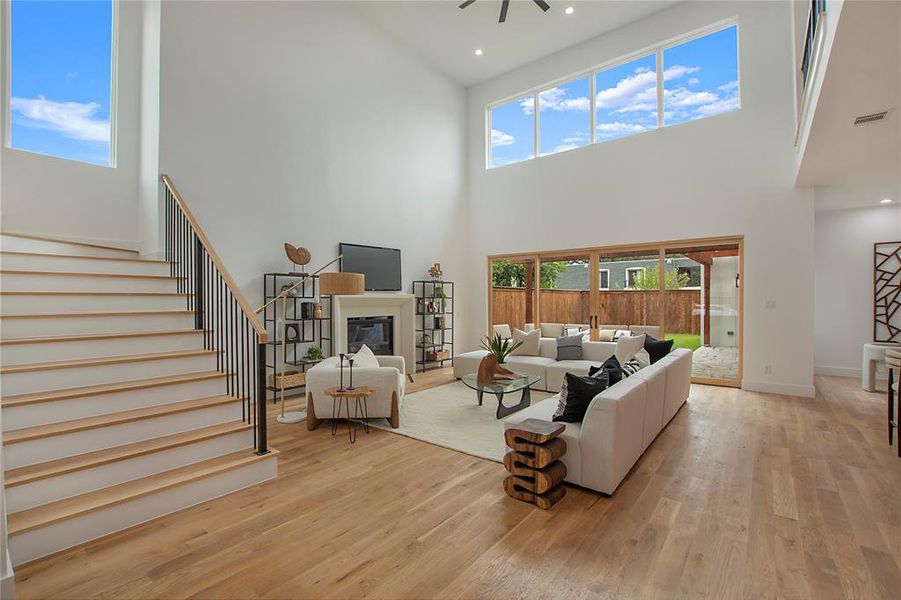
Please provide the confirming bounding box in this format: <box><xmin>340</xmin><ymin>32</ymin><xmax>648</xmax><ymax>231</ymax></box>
<box><xmin>468</xmin><ymin>2</ymin><xmax>814</xmax><ymax>395</ymax></box>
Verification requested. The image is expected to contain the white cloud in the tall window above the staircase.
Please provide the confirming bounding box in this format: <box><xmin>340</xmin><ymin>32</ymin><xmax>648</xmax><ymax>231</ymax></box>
<box><xmin>10</xmin><ymin>96</ymin><xmax>110</xmax><ymax>142</ymax></box>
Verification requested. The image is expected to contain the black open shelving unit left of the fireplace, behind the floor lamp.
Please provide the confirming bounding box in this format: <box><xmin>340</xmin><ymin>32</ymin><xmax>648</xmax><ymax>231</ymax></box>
<box><xmin>263</xmin><ymin>273</ymin><xmax>332</xmax><ymax>401</ymax></box>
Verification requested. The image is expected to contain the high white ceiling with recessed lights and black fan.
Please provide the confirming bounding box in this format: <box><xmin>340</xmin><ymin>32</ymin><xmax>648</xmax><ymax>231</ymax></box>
<box><xmin>349</xmin><ymin>0</ymin><xmax>677</xmax><ymax>86</ymax></box>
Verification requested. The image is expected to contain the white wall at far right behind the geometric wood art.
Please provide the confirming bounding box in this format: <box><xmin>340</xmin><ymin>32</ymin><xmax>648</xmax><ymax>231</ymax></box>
<box><xmin>815</xmin><ymin>203</ymin><xmax>901</xmax><ymax>377</ymax></box>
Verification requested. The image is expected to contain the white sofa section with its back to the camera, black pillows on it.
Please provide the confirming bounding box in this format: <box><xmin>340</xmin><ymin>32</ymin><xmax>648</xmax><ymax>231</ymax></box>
<box><xmin>504</xmin><ymin>342</ymin><xmax>692</xmax><ymax>494</ymax></box>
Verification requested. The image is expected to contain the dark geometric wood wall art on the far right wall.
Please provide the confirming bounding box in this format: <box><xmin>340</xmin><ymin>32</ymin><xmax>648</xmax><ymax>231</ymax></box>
<box><xmin>873</xmin><ymin>242</ymin><xmax>901</xmax><ymax>342</ymax></box>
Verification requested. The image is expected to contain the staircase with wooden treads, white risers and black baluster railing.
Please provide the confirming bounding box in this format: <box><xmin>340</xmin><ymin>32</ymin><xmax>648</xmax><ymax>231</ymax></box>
<box><xmin>0</xmin><ymin>176</ymin><xmax>277</xmax><ymax>564</ymax></box>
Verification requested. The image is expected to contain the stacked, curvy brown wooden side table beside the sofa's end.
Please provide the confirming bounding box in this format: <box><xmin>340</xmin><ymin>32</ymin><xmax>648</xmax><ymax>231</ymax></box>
<box><xmin>504</xmin><ymin>419</ymin><xmax>566</xmax><ymax>510</ymax></box>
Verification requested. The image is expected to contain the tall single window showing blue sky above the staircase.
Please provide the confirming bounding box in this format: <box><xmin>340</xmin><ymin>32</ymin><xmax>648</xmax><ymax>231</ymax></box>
<box><xmin>9</xmin><ymin>0</ymin><xmax>113</xmax><ymax>166</ymax></box>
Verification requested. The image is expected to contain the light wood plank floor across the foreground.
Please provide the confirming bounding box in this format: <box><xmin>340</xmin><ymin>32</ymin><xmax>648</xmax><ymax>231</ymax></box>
<box><xmin>17</xmin><ymin>371</ymin><xmax>901</xmax><ymax>598</ymax></box>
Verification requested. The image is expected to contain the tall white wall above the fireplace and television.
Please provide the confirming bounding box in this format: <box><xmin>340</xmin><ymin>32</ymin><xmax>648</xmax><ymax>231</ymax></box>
<box><xmin>160</xmin><ymin>2</ymin><xmax>468</xmax><ymax>341</ymax></box>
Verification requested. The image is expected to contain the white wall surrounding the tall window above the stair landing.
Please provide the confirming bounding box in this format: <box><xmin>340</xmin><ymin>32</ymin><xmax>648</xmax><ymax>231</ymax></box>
<box><xmin>0</xmin><ymin>2</ymin><xmax>142</xmax><ymax>247</ymax></box>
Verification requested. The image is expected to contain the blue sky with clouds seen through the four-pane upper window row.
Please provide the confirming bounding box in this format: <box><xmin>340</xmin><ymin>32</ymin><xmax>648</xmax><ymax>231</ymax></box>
<box><xmin>491</xmin><ymin>26</ymin><xmax>739</xmax><ymax>166</ymax></box>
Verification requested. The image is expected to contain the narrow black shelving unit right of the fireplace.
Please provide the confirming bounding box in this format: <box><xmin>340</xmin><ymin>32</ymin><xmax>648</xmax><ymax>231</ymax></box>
<box><xmin>413</xmin><ymin>280</ymin><xmax>454</xmax><ymax>371</ymax></box>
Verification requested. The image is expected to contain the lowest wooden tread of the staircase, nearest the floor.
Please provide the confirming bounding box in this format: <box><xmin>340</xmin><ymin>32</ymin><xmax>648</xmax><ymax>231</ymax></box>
<box><xmin>8</xmin><ymin>448</ymin><xmax>278</xmax><ymax>536</ymax></box>
